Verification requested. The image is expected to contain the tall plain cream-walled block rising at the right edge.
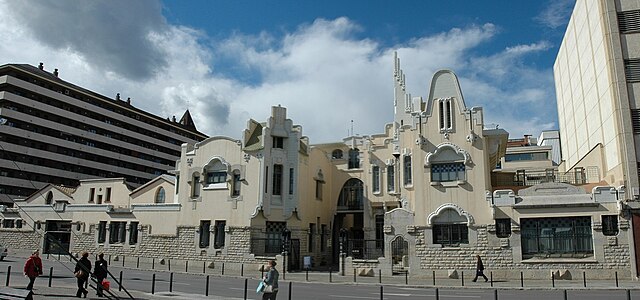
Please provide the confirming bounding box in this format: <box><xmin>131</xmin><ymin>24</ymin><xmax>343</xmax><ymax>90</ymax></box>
<box><xmin>554</xmin><ymin>0</ymin><xmax>640</xmax><ymax>275</ymax></box>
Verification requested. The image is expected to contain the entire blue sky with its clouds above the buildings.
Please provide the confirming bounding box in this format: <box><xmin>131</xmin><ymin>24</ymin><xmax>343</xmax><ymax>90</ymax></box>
<box><xmin>0</xmin><ymin>0</ymin><xmax>574</xmax><ymax>144</ymax></box>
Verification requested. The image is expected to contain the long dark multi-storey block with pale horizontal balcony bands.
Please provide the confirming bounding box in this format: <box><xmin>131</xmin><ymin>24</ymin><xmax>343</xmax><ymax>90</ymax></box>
<box><xmin>0</xmin><ymin>64</ymin><xmax>206</xmax><ymax>205</ymax></box>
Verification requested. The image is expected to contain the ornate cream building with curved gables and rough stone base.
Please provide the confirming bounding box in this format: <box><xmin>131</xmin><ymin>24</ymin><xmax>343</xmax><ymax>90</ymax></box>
<box><xmin>0</xmin><ymin>53</ymin><xmax>633</xmax><ymax>278</ymax></box>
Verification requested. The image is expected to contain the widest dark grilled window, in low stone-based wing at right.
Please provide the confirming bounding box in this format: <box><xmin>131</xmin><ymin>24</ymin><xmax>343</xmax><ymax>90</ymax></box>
<box><xmin>520</xmin><ymin>217</ymin><xmax>593</xmax><ymax>258</ymax></box>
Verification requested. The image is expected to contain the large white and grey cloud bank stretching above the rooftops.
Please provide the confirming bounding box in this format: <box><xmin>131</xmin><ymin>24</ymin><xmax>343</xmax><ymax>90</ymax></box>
<box><xmin>0</xmin><ymin>0</ymin><xmax>556</xmax><ymax>143</ymax></box>
